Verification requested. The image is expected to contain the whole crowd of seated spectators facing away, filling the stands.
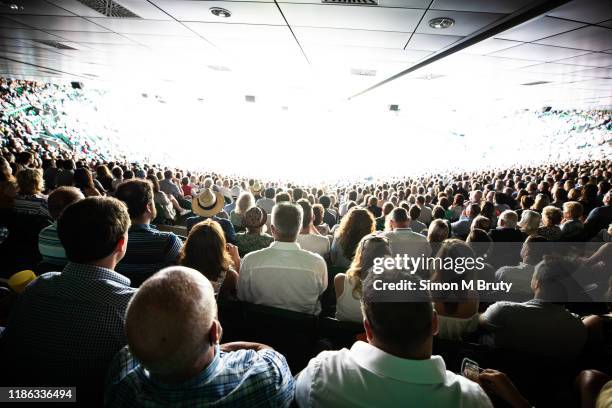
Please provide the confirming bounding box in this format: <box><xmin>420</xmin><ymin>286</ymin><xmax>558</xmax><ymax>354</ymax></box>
<box><xmin>0</xmin><ymin>78</ymin><xmax>612</xmax><ymax>407</ymax></box>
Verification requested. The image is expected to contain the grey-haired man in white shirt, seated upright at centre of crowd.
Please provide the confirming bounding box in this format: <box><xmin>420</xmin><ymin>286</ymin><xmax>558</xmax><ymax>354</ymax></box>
<box><xmin>238</xmin><ymin>202</ymin><xmax>327</xmax><ymax>315</ymax></box>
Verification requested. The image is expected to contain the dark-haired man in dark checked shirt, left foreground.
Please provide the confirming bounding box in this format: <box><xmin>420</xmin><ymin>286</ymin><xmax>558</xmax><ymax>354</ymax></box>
<box><xmin>3</xmin><ymin>197</ymin><xmax>134</xmax><ymax>388</ymax></box>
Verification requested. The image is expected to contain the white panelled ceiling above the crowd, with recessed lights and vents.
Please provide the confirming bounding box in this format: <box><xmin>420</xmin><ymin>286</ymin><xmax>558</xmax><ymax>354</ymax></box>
<box><xmin>0</xmin><ymin>0</ymin><xmax>612</xmax><ymax>109</ymax></box>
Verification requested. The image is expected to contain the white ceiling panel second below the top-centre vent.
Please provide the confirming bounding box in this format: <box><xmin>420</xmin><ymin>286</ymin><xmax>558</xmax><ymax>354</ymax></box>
<box><xmin>293</xmin><ymin>27</ymin><xmax>410</xmax><ymax>48</ymax></box>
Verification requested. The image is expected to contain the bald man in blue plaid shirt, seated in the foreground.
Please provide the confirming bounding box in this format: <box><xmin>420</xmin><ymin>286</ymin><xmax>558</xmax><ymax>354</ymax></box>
<box><xmin>104</xmin><ymin>266</ymin><xmax>295</xmax><ymax>407</ymax></box>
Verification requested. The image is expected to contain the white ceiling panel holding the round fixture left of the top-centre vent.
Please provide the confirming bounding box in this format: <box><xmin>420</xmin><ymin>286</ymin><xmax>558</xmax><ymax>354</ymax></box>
<box><xmin>148</xmin><ymin>0</ymin><xmax>285</xmax><ymax>25</ymax></box>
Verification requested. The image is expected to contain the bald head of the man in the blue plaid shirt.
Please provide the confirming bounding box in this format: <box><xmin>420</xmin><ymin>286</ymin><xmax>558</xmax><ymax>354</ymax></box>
<box><xmin>125</xmin><ymin>266</ymin><xmax>218</xmax><ymax>377</ymax></box>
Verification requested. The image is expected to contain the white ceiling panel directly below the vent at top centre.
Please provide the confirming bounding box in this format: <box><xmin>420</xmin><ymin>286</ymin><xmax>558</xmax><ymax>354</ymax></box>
<box><xmin>280</xmin><ymin>3</ymin><xmax>423</xmax><ymax>32</ymax></box>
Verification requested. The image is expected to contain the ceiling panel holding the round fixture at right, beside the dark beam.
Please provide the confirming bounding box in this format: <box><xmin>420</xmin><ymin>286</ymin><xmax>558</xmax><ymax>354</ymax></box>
<box><xmin>414</xmin><ymin>10</ymin><xmax>504</xmax><ymax>36</ymax></box>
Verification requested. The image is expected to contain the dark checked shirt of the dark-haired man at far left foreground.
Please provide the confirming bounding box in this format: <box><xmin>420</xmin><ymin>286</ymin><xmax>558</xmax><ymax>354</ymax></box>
<box><xmin>3</xmin><ymin>263</ymin><xmax>134</xmax><ymax>381</ymax></box>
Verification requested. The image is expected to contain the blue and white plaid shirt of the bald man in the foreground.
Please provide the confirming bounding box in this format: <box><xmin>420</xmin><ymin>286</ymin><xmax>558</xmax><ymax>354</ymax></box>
<box><xmin>104</xmin><ymin>346</ymin><xmax>295</xmax><ymax>408</ymax></box>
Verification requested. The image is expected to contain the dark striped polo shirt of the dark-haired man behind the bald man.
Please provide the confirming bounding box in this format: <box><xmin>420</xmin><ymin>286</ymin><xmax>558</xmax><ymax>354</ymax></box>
<box><xmin>115</xmin><ymin>224</ymin><xmax>183</xmax><ymax>287</ymax></box>
